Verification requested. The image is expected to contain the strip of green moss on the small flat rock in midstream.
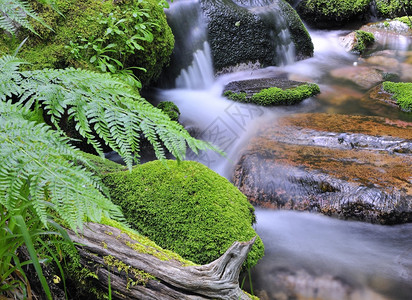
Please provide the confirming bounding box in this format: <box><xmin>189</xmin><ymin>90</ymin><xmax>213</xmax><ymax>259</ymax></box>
<box><xmin>224</xmin><ymin>83</ymin><xmax>320</xmax><ymax>106</ymax></box>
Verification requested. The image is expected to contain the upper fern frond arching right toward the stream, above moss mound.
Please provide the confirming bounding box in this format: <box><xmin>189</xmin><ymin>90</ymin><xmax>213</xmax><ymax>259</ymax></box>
<box><xmin>0</xmin><ymin>56</ymin><xmax>216</xmax><ymax>168</ymax></box>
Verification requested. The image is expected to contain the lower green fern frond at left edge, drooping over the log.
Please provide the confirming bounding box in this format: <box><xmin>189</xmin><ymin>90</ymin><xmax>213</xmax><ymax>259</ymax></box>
<box><xmin>0</xmin><ymin>101</ymin><xmax>122</xmax><ymax>230</ymax></box>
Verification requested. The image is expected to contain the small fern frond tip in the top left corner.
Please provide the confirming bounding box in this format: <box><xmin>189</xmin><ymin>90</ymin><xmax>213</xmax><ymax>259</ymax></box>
<box><xmin>0</xmin><ymin>0</ymin><xmax>52</xmax><ymax>34</ymax></box>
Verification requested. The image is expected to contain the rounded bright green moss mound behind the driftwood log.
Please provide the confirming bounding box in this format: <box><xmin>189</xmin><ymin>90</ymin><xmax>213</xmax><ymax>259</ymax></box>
<box><xmin>103</xmin><ymin>161</ymin><xmax>264</xmax><ymax>266</ymax></box>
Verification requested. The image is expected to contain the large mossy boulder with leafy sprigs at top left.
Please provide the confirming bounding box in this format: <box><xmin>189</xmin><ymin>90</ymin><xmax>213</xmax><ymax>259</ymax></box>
<box><xmin>0</xmin><ymin>0</ymin><xmax>174</xmax><ymax>84</ymax></box>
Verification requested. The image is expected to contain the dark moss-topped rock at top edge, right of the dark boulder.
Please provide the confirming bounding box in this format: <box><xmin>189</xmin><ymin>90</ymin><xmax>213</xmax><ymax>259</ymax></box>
<box><xmin>296</xmin><ymin>0</ymin><xmax>371</xmax><ymax>28</ymax></box>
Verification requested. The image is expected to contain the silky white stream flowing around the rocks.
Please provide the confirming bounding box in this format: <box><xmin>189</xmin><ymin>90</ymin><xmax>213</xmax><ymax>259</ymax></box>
<box><xmin>151</xmin><ymin>2</ymin><xmax>412</xmax><ymax>300</ymax></box>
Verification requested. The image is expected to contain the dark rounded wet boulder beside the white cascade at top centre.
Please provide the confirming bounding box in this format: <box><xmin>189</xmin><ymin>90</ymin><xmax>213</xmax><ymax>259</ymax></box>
<box><xmin>200</xmin><ymin>0</ymin><xmax>313</xmax><ymax>72</ymax></box>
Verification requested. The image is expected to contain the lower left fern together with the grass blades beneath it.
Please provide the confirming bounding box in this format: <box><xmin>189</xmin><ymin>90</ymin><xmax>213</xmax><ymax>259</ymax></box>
<box><xmin>0</xmin><ymin>101</ymin><xmax>122</xmax><ymax>298</ymax></box>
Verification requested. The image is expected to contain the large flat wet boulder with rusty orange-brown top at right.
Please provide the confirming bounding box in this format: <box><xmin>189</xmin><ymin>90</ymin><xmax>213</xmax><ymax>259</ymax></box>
<box><xmin>233</xmin><ymin>114</ymin><xmax>412</xmax><ymax>224</ymax></box>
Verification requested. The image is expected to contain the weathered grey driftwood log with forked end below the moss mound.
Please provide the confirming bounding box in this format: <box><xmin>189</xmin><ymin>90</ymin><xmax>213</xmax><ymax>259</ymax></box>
<box><xmin>70</xmin><ymin>223</ymin><xmax>255</xmax><ymax>300</ymax></box>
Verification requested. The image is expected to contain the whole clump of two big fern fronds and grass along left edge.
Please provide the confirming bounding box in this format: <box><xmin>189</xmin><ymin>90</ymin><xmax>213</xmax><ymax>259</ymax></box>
<box><xmin>0</xmin><ymin>56</ymin><xmax>219</xmax><ymax>299</ymax></box>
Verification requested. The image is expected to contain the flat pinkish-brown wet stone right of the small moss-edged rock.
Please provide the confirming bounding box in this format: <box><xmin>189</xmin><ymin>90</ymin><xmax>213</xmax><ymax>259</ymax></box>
<box><xmin>330</xmin><ymin>66</ymin><xmax>384</xmax><ymax>89</ymax></box>
